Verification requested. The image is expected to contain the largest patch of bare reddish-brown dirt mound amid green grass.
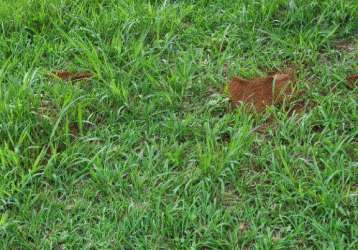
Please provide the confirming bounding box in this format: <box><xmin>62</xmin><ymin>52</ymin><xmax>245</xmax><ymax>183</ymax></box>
<box><xmin>229</xmin><ymin>73</ymin><xmax>294</xmax><ymax>112</ymax></box>
